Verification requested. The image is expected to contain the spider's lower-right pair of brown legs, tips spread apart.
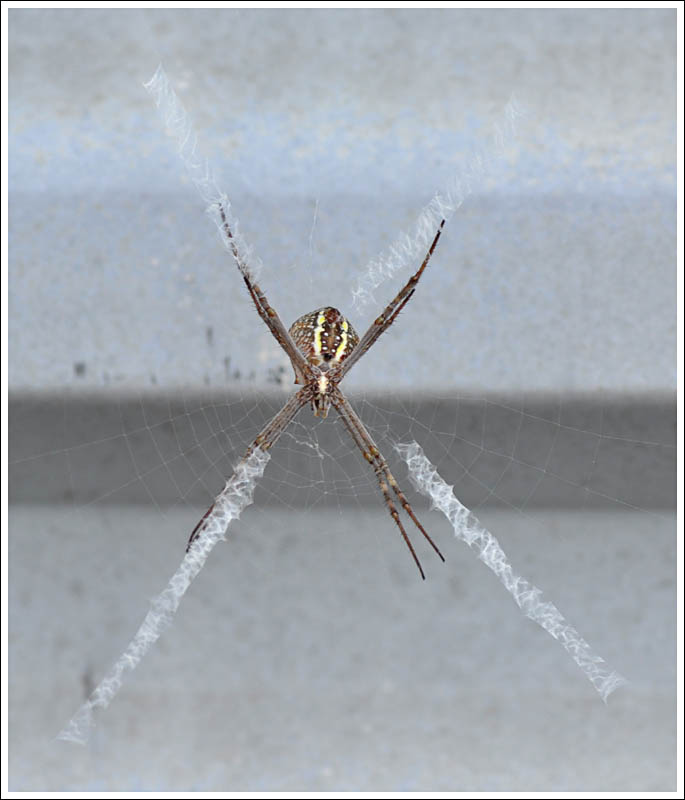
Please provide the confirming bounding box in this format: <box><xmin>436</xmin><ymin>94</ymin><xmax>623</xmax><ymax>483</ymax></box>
<box><xmin>331</xmin><ymin>388</ymin><xmax>445</xmax><ymax>580</ymax></box>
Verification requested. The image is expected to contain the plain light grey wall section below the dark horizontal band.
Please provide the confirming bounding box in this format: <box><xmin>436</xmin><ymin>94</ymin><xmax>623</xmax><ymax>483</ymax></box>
<box><xmin>9</xmin><ymin>504</ymin><xmax>675</xmax><ymax>792</ymax></box>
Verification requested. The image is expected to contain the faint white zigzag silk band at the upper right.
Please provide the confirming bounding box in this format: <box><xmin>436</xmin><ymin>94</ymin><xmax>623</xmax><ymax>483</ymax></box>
<box><xmin>352</xmin><ymin>96</ymin><xmax>522</xmax><ymax>310</ymax></box>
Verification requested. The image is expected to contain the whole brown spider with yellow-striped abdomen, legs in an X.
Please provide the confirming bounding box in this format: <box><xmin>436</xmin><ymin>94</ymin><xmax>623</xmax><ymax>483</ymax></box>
<box><xmin>186</xmin><ymin>203</ymin><xmax>445</xmax><ymax>580</ymax></box>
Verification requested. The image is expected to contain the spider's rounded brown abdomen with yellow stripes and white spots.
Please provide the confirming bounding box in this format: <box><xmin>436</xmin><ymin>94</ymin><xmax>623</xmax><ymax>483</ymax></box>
<box><xmin>289</xmin><ymin>306</ymin><xmax>359</xmax><ymax>380</ymax></box>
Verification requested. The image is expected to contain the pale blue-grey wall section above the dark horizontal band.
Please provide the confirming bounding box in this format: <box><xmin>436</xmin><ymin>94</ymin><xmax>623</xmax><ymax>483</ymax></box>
<box><xmin>9</xmin><ymin>9</ymin><xmax>676</xmax><ymax>392</ymax></box>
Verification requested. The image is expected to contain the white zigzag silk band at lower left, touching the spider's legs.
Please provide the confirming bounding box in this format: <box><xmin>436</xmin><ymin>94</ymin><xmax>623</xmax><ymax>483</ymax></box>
<box><xmin>57</xmin><ymin>448</ymin><xmax>269</xmax><ymax>744</ymax></box>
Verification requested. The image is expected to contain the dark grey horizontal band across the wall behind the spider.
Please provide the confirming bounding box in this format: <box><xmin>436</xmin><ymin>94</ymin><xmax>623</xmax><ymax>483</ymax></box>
<box><xmin>9</xmin><ymin>391</ymin><xmax>676</xmax><ymax>510</ymax></box>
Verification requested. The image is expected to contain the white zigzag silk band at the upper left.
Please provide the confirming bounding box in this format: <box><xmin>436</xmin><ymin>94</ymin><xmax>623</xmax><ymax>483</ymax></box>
<box><xmin>143</xmin><ymin>64</ymin><xmax>261</xmax><ymax>281</ymax></box>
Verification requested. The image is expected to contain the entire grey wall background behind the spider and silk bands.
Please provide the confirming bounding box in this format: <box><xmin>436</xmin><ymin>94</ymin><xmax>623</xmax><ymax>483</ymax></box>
<box><xmin>8</xmin><ymin>9</ymin><xmax>676</xmax><ymax>791</ymax></box>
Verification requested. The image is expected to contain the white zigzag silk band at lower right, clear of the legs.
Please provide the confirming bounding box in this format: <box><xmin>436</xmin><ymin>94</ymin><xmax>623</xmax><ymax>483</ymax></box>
<box><xmin>395</xmin><ymin>442</ymin><xmax>626</xmax><ymax>703</ymax></box>
